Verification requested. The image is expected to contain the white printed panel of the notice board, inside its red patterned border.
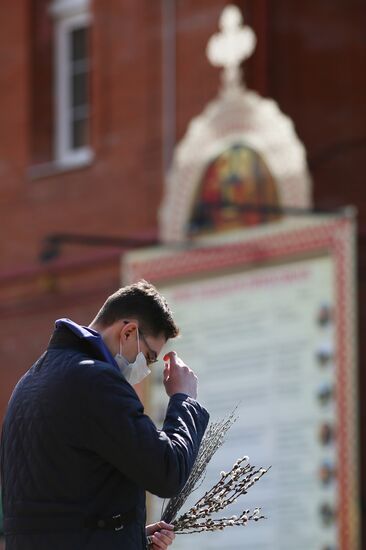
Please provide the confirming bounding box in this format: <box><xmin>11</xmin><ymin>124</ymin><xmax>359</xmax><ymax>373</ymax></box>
<box><xmin>147</xmin><ymin>255</ymin><xmax>338</xmax><ymax>550</ymax></box>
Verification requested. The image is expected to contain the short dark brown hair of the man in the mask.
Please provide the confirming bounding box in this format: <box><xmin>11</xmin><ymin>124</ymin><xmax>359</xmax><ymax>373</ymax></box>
<box><xmin>95</xmin><ymin>280</ymin><xmax>179</xmax><ymax>340</ymax></box>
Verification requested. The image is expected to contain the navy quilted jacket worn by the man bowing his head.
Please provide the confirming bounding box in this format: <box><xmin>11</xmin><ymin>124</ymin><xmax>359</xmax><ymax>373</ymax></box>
<box><xmin>1</xmin><ymin>327</ymin><xmax>208</xmax><ymax>550</ymax></box>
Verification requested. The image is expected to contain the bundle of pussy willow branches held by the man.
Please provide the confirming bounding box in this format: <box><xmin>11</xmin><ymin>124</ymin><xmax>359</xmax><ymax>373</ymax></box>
<box><xmin>161</xmin><ymin>409</ymin><xmax>269</xmax><ymax>534</ymax></box>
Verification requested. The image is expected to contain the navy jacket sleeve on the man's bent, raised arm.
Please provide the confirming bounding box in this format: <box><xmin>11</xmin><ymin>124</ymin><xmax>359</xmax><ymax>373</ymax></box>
<box><xmin>83</xmin><ymin>369</ymin><xmax>209</xmax><ymax>498</ymax></box>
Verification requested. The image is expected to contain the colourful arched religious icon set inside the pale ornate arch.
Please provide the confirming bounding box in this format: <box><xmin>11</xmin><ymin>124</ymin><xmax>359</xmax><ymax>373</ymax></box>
<box><xmin>189</xmin><ymin>144</ymin><xmax>281</xmax><ymax>236</ymax></box>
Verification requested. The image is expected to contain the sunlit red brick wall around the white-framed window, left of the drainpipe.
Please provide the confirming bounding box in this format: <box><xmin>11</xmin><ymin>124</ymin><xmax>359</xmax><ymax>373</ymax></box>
<box><xmin>0</xmin><ymin>2</ymin><xmax>156</xmax><ymax>266</ymax></box>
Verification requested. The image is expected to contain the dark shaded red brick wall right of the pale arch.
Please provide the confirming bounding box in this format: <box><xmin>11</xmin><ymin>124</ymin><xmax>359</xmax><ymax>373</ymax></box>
<box><xmin>268</xmin><ymin>0</ymin><xmax>366</xmax><ymax>220</ymax></box>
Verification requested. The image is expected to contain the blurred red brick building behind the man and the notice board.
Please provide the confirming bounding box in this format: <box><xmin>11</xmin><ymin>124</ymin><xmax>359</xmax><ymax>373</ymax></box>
<box><xmin>0</xmin><ymin>0</ymin><xmax>366</xmax><ymax>548</ymax></box>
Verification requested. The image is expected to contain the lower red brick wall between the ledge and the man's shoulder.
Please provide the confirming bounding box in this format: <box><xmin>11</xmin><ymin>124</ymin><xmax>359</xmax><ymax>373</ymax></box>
<box><xmin>0</xmin><ymin>254</ymin><xmax>119</xmax><ymax>418</ymax></box>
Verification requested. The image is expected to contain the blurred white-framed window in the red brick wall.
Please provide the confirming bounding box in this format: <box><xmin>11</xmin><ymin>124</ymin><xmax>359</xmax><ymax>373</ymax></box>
<box><xmin>51</xmin><ymin>0</ymin><xmax>93</xmax><ymax>167</ymax></box>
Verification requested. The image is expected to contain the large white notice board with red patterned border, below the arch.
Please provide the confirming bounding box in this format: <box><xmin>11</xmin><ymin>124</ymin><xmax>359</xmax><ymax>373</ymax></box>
<box><xmin>123</xmin><ymin>217</ymin><xmax>359</xmax><ymax>550</ymax></box>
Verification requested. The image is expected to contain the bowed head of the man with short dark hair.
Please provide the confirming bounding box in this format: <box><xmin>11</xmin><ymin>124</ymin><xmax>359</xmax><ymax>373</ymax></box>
<box><xmin>90</xmin><ymin>280</ymin><xmax>179</xmax><ymax>364</ymax></box>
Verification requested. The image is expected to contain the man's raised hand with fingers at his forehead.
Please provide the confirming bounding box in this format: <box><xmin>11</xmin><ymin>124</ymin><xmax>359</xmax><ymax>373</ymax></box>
<box><xmin>164</xmin><ymin>351</ymin><xmax>198</xmax><ymax>399</ymax></box>
